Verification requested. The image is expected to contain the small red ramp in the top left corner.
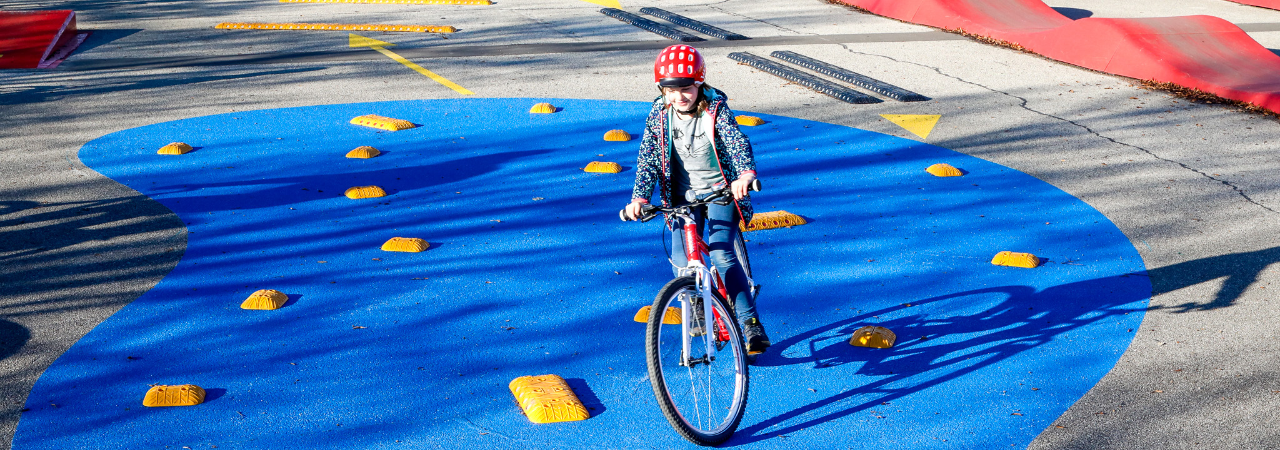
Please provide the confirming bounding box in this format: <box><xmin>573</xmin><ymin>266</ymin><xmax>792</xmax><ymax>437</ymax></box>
<box><xmin>0</xmin><ymin>10</ymin><xmax>77</xmax><ymax>69</ymax></box>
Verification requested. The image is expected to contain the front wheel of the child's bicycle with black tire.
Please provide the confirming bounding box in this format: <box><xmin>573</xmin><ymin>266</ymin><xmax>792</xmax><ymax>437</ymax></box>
<box><xmin>645</xmin><ymin>276</ymin><xmax>749</xmax><ymax>445</ymax></box>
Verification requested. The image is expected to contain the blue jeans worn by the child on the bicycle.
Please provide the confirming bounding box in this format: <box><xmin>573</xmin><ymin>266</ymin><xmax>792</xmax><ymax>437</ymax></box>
<box><xmin>671</xmin><ymin>202</ymin><xmax>758</xmax><ymax>323</ymax></box>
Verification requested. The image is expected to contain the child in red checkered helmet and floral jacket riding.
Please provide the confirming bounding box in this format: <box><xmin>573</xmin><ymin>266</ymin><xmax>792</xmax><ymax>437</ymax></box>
<box><xmin>626</xmin><ymin>45</ymin><xmax>771</xmax><ymax>354</ymax></box>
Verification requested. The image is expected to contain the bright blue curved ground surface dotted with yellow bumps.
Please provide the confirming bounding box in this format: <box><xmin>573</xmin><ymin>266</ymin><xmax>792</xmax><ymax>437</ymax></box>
<box><xmin>14</xmin><ymin>98</ymin><xmax>1151</xmax><ymax>450</ymax></box>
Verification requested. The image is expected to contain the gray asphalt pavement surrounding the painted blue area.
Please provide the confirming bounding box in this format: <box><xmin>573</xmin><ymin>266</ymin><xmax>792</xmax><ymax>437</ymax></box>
<box><xmin>0</xmin><ymin>0</ymin><xmax>1280</xmax><ymax>449</ymax></box>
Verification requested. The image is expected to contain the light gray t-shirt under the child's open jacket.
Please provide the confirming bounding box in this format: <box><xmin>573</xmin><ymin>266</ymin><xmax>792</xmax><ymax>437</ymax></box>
<box><xmin>668</xmin><ymin>111</ymin><xmax>724</xmax><ymax>198</ymax></box>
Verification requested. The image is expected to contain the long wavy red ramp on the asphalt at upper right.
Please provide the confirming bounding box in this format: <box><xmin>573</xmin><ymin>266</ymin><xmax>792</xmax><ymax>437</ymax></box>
<box><xmin>840</xmin><ymin>0</ymin><xmax>1280</xmax><ymax>113</ymax></box>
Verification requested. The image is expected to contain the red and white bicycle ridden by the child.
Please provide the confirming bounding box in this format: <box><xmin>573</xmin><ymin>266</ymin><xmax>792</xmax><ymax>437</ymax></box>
<box><xmin>618</xmin><ymin>180</ymin><xmax>760</xmax><ymax>445</ymax></box>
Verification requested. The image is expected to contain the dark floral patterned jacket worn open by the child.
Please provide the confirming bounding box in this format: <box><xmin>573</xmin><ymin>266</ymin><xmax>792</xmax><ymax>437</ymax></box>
<box><xmin>631</xmin><ymin>87</ymin><xmax>755</xmax><ymax>222</ymax></box>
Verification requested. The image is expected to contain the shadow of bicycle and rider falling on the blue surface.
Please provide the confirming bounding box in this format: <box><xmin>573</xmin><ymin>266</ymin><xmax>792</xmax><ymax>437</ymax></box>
<box><xmin>727</xmin><ymin>274</ymin><xmax>1151</xmax><ymax>445</ymax></box>
